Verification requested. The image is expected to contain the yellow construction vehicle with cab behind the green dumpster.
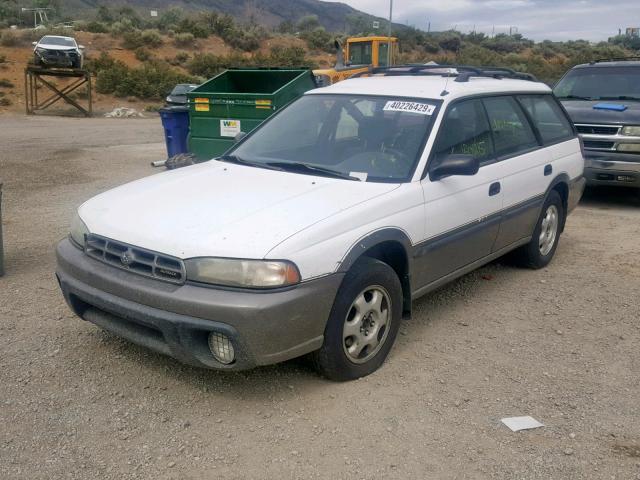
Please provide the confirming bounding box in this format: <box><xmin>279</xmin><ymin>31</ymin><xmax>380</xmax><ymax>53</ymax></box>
<box><xmin>313</xmin><ymin>37</ymin><xmax>399</xmax><ymax>87</ymax></box>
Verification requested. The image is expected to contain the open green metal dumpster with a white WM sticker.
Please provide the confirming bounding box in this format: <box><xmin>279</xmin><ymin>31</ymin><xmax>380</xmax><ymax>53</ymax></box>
<box><xmin>187</xmin><ymin>68</ymin><xmax>316</xmax><ymax>160</ymax></box>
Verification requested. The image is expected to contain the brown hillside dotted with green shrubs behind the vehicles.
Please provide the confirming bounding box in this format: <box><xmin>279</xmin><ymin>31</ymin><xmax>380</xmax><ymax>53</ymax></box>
<box><xmin>0</xmin><ymin>0</ymin><xmax>640</xmax><ymax>116</ymax></box>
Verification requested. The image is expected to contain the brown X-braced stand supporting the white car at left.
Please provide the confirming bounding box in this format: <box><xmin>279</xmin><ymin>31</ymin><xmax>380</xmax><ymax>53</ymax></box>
<box><xmin>24</xmin><ymin>65</ymin><xmax>93</xmax><ymax>117</ymax></box>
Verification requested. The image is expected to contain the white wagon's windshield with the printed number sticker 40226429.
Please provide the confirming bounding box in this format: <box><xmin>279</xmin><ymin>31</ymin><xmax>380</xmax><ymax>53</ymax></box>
<box><xmin>230</xmin><ymin>94</ymin><xmax>440</xmax><ymax>182</ymax></box>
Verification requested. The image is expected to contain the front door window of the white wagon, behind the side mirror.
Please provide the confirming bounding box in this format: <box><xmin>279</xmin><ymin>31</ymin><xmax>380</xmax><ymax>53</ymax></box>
<box><xmin>433</xmin><ymin>100</ymin><xmax>493</xmax><ymax>162</ymax></box>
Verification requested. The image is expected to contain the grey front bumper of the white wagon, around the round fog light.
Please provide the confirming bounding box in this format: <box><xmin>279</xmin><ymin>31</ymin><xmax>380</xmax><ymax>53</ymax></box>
<box><xmin>56</xmin><ymin>239</ymin><xmax>344</xmax><ymax>370</ymax></box>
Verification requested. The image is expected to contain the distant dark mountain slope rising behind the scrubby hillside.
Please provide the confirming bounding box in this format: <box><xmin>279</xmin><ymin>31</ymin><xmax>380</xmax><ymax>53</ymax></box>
<box><xmin>63</xmin><ymin>0</ymin><xmax>392</xmax><ymax>31</ymax></box>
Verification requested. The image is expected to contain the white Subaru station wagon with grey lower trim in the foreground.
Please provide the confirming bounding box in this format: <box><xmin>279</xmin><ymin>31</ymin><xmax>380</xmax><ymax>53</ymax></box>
<box><xmin>57</xmin><ymin>67</ymin><xmax>584</xmax><ymax>380</ymax></box>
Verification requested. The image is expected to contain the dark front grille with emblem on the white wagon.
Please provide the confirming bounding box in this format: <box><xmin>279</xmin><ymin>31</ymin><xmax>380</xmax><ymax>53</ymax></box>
<box><xmin>84</xmin><ymin>234</ymin><xmax>186</xmax><ymax>284</ymax></box>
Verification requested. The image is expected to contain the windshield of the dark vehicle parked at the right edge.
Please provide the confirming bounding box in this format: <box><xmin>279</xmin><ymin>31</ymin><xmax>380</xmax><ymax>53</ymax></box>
<box><xmin>553</xmin><ymin>67</ymin><xmax>640</xmax><ymax>100</ymax></box>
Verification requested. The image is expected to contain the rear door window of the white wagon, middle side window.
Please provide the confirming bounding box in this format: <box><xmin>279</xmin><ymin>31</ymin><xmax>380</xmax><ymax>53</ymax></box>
<box><xmin>483</xmin><ymin>97</ymin><xmax>539</xmax><ymax>157</ymax></box>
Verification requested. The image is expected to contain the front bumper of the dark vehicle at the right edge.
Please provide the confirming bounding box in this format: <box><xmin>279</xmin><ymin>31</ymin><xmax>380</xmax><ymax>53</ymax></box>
<box><xmin>584</xmin><ymin>151</ymin><xmax>640</xmax><ymax>188</ymax></box>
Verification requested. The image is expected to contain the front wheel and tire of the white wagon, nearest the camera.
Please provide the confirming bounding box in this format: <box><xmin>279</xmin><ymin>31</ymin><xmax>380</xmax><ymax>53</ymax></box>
<box><xmin>312</xmin><ymin>257</ymin><xmax>402</xmax><ymax>381</ymax></box>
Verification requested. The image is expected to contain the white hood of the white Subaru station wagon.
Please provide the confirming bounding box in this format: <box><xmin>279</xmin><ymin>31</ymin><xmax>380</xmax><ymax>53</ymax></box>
<box><xmin>79</xmin><ymin>161</ymin><xmax>398</xmax><ymax>258</ymax></box>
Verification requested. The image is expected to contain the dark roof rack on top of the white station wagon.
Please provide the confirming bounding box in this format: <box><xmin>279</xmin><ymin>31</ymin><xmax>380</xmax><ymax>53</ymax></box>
<box><xmin>351</xmin><ymin>63</ymin><xmax>538</xmax><ymax>82</ymax></box>
